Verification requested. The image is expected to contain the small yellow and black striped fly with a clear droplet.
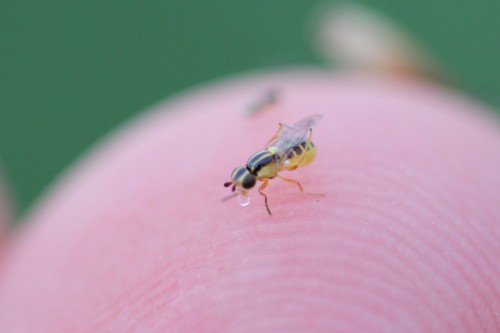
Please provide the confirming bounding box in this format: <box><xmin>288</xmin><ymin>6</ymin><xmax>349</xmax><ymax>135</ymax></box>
<box><xmin>224</xmin><ymin>115</ymin><xmax>323</xmax><ymax>215</ymax></box>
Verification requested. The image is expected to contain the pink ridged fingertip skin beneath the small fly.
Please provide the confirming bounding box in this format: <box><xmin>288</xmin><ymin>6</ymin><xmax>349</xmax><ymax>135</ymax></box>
<box><xmin>0</xmin><ymin>70</ymin><xmax>500</xmax><ymax>332</ymax></box>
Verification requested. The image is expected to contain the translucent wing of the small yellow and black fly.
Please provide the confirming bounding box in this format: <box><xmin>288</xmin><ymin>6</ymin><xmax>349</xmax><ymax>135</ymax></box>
<box><xmin>268</xmin><ymin>115</ymin><xmax>323</xmax><ymax>165</ymax></box>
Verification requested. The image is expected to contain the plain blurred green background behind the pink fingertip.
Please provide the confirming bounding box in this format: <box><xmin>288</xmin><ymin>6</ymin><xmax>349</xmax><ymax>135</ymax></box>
<box><xmin>0</xmin><ymin>0</ymin><xmax>500</xmax><ymax>212</ymax></box>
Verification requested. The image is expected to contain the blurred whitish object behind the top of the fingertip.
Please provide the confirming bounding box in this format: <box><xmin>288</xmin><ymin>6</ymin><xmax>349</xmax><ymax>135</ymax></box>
<box><xmin>312</xmin><ymin>3</ymin><xmax>445</xmax><ymax>79</ymax></box>
